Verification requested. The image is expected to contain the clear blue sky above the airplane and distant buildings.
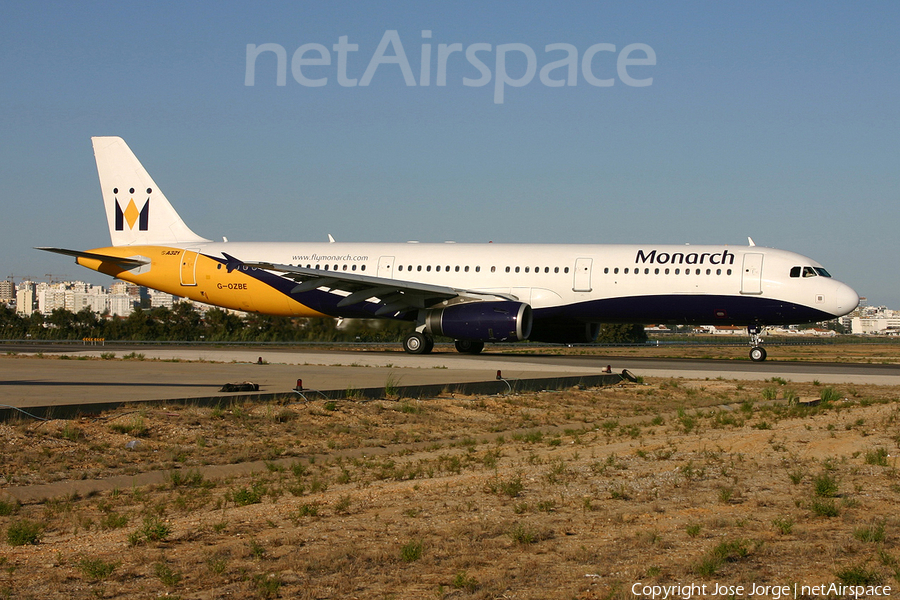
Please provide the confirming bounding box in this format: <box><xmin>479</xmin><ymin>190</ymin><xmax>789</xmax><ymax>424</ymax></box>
<box><xmin>0</xmin><ymin>1</ymin><xmax>900</xmax><ymax>309</ymax></box>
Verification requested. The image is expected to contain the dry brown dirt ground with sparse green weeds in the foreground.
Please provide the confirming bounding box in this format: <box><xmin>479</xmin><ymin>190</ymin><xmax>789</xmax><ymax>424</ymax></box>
<box><xmin>0</xmin><ymin>368</ymin><xmax>900</xmax><ymax>599</ymax></box>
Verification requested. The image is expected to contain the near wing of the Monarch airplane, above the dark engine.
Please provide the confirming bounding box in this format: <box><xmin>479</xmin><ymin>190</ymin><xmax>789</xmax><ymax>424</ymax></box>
<box><xmin>222</xmin><ymin>252</ymin><xmax>515</xmax><ymax>317</ymax></box>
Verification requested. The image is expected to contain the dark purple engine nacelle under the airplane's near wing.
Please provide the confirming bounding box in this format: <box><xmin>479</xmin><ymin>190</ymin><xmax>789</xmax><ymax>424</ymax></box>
<box><xmin>425</xmin><ymin>300</ymin><xmax>531</xmax><ymax>342</ymax></box>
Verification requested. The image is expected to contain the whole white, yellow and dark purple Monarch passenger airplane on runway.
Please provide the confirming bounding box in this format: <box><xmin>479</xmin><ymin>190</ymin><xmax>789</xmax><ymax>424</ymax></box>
<box><xmin>38</xmin><ymin>137</ymin><xmax>859</xmax><ymax>362</ymax></box>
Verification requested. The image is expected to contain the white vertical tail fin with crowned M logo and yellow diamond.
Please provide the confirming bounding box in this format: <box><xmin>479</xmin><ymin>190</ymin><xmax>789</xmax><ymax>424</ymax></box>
<box><xmin>91</xmin><ymin>137</ymin><xmax>209</xmax><ymax>246</ymax></box>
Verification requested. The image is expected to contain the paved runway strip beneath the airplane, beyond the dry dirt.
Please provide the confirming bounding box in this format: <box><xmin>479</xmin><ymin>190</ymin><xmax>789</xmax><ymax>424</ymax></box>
<box><xmin>0</xmin><ymin>346</ymin><xmax>900</xmax><ymax>408</ymax></box>
